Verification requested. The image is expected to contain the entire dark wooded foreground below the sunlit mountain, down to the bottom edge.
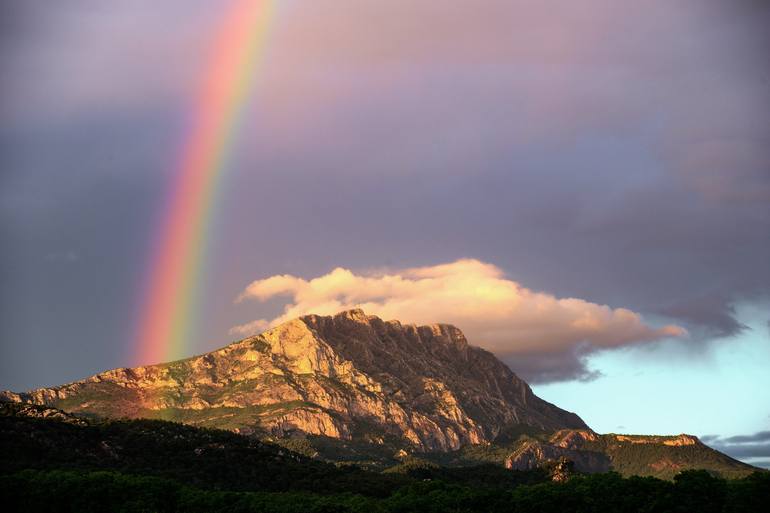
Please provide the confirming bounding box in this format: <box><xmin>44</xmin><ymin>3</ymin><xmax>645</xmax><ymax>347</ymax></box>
<box><xmin>0</xmin><ymin>404</ymin><xmax>770</xmax><ymax>513</ymax></box>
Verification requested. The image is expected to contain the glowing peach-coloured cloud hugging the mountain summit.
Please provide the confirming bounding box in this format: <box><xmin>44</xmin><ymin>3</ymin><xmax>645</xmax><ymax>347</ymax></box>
<box><xmin>231</xmin><ymin>259</ymin><xmax>686</xmax><ymax>381</ymax></box>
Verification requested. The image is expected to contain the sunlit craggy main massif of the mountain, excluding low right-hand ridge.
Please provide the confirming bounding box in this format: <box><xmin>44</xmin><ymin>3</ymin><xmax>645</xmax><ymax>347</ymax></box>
<box><xmin>8</xmin><ymin>310</ymin><xmax>588</xmax><ymax>451</ymax></box>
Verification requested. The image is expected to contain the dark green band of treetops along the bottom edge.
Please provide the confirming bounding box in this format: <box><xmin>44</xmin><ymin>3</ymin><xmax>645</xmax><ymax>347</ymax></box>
<box><xmin>0</xmin><ymin>470</ymin><xmax>770</xmax><ymax>513</ymax></box>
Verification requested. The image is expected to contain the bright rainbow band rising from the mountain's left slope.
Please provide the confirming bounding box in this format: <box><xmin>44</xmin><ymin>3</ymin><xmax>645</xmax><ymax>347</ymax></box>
<box><xmin>134</xmin><ymin>0</ymin><xmax>276</xmax><ymax>364</ymax></box>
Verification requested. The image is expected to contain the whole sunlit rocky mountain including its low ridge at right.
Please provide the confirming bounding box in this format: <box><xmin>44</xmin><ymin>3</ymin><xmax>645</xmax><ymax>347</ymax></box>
<box><xmin>0</xmin><ymin>309</ymin><xmax>754</xmax><ymax>477</ymax></box>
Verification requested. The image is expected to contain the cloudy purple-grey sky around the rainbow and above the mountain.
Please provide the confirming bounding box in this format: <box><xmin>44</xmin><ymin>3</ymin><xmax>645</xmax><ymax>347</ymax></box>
<box><xmin>0</xmin><ymin>0</ymin><xmax>770</xmax><ymax>466</ymax></box>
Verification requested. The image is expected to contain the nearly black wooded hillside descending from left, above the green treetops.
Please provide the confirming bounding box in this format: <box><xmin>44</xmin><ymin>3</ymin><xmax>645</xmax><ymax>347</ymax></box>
<box><xmin>0</xmin><ymin>403</ymin><xmax>405</xmax><ymax>496</ymax></box>
